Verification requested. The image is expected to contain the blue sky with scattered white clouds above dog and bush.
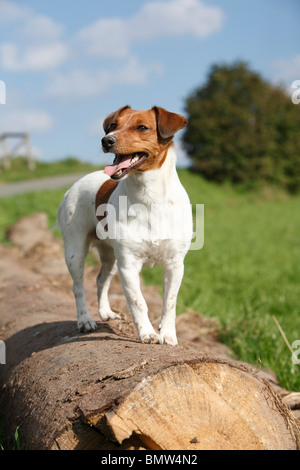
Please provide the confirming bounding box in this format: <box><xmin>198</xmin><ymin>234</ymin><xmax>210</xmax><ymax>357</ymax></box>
<box><xmin>0</xmin><ymin>0</ymin><xmax>300</xmax><ymax>165</ymax></box>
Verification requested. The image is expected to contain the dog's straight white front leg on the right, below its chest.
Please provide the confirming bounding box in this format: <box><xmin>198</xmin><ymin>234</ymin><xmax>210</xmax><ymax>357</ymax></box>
<box><xmin>159</xmin><ymin>261</ymin><xmax>184</xmax><ymax>346</ymax></box>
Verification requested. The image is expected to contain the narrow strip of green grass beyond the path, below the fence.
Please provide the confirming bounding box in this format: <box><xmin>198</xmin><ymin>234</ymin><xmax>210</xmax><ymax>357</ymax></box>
<box><xmin>0</xmin><ymin>157</ymin><xmax>100</xmax><ymax>183</ymax></box>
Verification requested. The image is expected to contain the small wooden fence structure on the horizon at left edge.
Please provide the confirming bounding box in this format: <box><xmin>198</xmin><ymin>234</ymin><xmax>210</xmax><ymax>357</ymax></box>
<box><xmin>0</xmin><ymin>132</ymin><xmax>35</xmax><ymax>170</ymax></box>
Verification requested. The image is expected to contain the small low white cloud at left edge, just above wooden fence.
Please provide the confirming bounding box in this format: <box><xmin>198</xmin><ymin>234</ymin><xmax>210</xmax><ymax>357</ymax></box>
<box><xmin>0</xmin><ymin>109</ymin><xmax>53</xmax><ymax>133</ymax></box>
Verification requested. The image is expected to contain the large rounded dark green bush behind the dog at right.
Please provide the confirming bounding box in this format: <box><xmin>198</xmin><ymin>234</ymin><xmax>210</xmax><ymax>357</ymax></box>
<box><xmin>183</xmin><ymin>62</ymin><xmax>300</xmax><ymax>192</ymax></box>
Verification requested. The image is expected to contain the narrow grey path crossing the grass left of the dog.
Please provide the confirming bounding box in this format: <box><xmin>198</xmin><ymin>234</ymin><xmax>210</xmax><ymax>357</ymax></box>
<box><xmin>0</xmin><ymin>173</ymin><xmax>86</xmax><ymax>198</ymax></box>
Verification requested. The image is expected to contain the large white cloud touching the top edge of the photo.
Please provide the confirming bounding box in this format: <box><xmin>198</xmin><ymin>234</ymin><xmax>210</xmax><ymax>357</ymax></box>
<box><xmin>77</xmin><ymin>0</ymin><xmax>224</xmax><ymax>58</ymax></box>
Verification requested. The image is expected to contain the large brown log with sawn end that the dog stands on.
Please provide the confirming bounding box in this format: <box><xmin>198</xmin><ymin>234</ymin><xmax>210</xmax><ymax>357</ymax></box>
<box><xmin>0</xmin><ymin>215</ymin><xmax>300</xmax><ymax>450</ymax></box>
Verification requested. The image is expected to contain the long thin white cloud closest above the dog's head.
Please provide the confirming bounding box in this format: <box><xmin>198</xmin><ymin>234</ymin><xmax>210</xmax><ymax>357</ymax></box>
<box><xmin>46</xmin><ymin>57</ymin><xmax>163</xmax><ymax>97</ymax></box>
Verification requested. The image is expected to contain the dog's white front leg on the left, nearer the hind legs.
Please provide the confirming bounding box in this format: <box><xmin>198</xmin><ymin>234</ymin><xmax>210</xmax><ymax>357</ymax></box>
<box><xmin>118</xmin><ymin>258</ymin><xmax>160</xmax><ymax>343</ymax></box>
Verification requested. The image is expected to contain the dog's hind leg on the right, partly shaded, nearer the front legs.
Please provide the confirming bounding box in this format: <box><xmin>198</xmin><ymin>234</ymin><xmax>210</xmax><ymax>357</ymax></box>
<box><xmin>97</xmin><ymin>246</ymin><xmax>121</xmax><ymax>321</ymax></box>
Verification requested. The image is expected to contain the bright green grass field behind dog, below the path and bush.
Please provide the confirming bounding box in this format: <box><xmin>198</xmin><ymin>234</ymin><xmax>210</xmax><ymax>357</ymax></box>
<box><xmin>0</xmin><ymin>163</ymin><xmax>300</xmax><ymax>391</ymax></box>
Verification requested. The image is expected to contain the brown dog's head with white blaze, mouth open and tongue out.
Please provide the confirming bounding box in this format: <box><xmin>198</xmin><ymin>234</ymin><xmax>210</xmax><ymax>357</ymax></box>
<box><xmin>102</xmin><ymin>106</ymin><xmax>187</xmax><ymax>180</ymax></box>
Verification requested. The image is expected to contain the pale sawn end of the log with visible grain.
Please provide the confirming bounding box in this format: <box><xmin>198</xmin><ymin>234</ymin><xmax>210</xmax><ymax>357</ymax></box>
<box><xmin>52</xmin><ymin>358</ymin><xmax>299</xmax><ymax>450</ymax></box>
